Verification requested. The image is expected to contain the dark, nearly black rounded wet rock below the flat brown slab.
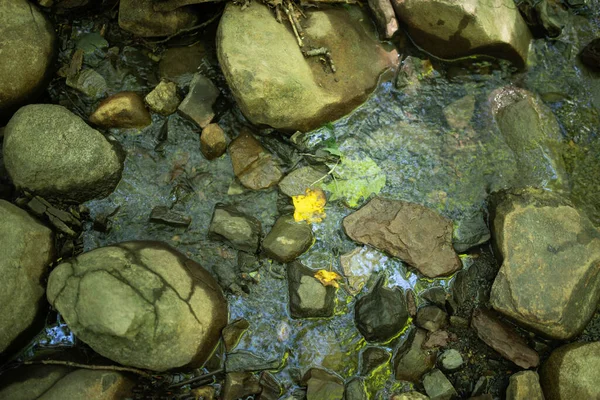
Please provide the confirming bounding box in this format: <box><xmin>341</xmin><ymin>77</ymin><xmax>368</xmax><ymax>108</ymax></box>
<box><xmin>354</xmin><ymin>278</ymin><xmax>408</xmax><ymax>342</ymax></box>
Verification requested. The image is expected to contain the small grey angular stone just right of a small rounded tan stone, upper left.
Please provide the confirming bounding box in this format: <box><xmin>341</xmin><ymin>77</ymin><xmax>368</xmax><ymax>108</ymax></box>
<box><xmin>177</xmin><ymin>74</ymin><xmax>220</xmax><ymax>128</ymax></box>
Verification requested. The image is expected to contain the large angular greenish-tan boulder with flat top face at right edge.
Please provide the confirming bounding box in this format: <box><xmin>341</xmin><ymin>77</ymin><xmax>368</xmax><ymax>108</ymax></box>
<box><xmin>490</xmin><ymin>189</ymin><xmax>600</xmax><ymax>340</ymax></box>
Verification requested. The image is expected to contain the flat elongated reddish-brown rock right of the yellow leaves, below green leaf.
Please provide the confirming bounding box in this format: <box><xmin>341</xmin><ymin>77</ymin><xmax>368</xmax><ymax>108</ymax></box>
<box><xmin>343</xmin><ymin>197</ymin><xmax>462</xmax><ymax>278</ymax></box>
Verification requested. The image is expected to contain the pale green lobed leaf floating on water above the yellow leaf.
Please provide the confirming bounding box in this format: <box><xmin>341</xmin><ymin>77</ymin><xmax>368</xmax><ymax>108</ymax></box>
<box><xmin>322</xmin><ymin>156</ymin><xmax>385</xmax><ymax>207</ymax></box>
